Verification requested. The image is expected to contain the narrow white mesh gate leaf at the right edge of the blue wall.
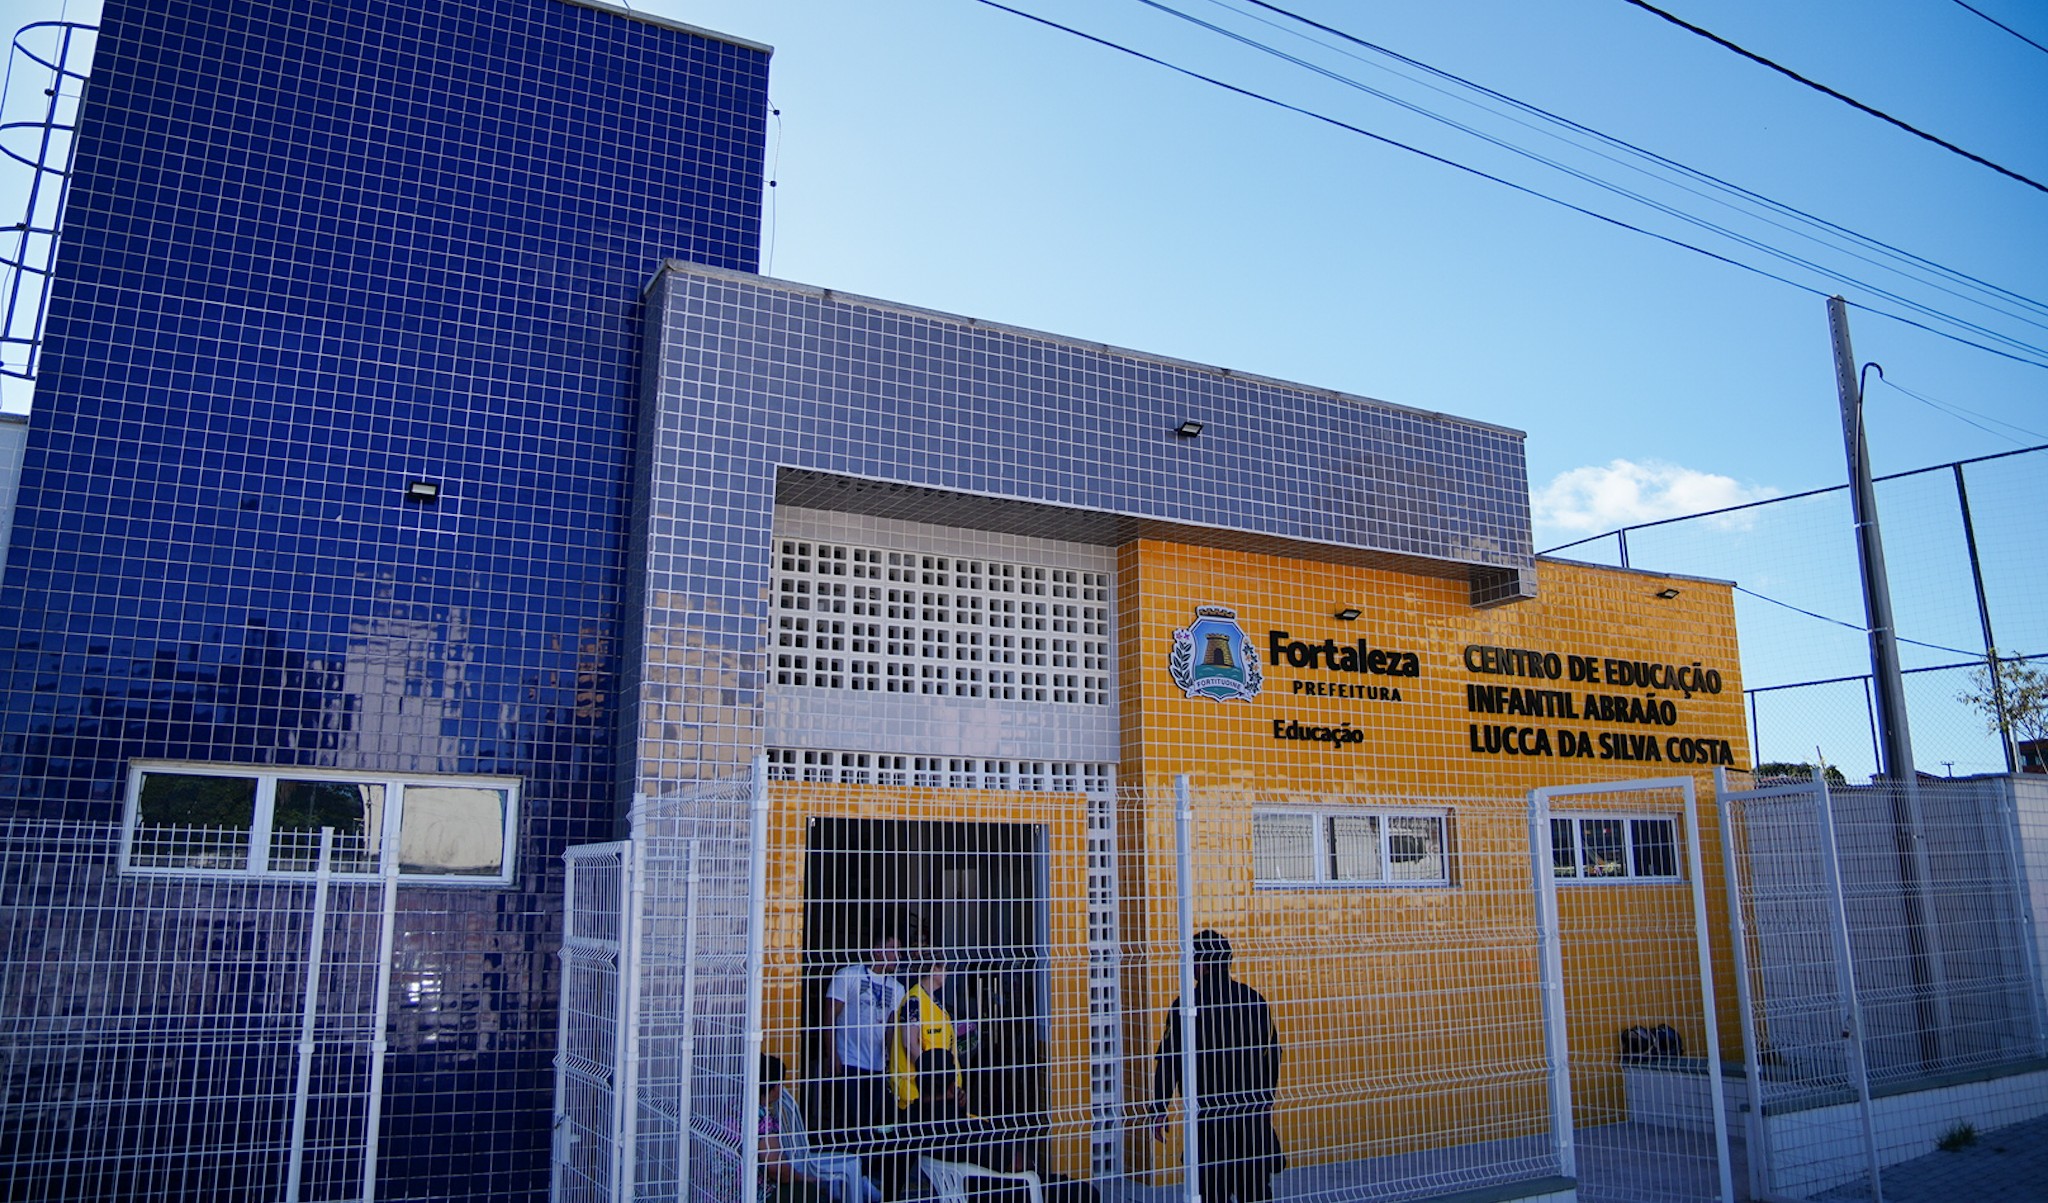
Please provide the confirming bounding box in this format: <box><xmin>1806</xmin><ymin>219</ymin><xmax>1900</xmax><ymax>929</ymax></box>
<box><xmin>551</xmin><ymin>840</ymin><xmax>637</xmax><ymax>1203</ymax></box>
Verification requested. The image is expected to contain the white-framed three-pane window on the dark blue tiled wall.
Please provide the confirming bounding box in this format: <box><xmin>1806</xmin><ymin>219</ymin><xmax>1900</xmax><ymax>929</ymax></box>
<box><xmin>121</xmin><ymin>760</ymin><xmax>518</xmax><ymax>885</ymax></box>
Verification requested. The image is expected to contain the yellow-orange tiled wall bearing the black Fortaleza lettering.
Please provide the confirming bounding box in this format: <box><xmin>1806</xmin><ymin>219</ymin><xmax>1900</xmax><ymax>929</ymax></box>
<box><xmin>1118</xmin><ymin>543</ymin><xmax>1749</xmax><ymax>1156</ymax></box>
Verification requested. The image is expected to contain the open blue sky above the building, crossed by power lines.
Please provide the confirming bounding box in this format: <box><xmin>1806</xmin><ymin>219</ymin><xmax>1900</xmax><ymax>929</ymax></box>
<box><xmin>645</xmin><ymin>0</ymin><xmax>2048</xmax><ymax>545</ymax></box>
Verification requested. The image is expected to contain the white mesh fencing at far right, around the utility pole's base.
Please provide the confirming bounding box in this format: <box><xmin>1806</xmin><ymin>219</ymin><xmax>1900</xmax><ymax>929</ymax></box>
<box><xmin>1724</xmin><ymin>779</ymin><xmax>2048</xmax><ymax>1199</ymax></box>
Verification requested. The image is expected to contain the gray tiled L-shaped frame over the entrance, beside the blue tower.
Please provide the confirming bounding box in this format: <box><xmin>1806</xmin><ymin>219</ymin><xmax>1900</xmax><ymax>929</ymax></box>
<box><xmin>623</xmin><ymin>262</ymin><xmax>1534</xmax><ymax>795</ymax></box>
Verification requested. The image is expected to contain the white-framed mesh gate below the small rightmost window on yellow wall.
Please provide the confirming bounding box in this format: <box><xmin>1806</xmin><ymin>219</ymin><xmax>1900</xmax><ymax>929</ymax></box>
<box><xmin>1530</xmin><ymin>777</ymin><xmax>1735</xmax><ymax>1203</ymax></box>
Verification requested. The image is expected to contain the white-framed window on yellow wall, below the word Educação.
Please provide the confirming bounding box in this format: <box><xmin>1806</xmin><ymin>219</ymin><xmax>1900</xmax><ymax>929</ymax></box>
<box><xmin>1251</xmin><ymin>807</ymin><xmax>1450</xmax><ymax>887</ymax></box>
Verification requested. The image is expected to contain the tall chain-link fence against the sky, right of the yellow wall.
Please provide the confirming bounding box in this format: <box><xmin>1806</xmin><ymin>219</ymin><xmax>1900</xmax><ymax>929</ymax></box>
<box><xmin>1552</xmin><ymin>447</ymin><xmax>2048</xmax><ymax>781</ymax></box>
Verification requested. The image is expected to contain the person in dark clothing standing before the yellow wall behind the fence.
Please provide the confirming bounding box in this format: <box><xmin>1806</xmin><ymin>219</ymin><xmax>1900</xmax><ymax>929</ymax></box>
<box><xmin>1153</xmin><ymin>930</ymin><xmax>1286</xmax><ymax>1203</ymax></box>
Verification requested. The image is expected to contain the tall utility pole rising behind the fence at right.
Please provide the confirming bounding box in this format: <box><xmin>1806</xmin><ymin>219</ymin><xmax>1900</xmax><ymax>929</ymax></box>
<box><xmin>1827</xmin><ymin>297</ymin><xmax>1950</xmax><ymax>1070</ymax></box>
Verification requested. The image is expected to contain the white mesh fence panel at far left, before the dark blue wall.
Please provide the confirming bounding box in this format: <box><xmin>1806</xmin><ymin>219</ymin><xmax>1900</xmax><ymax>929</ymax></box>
<box><xmin>0</xmin><ymin>820</ymin><xmax>383</xmax><ymax>1201</ymax></box>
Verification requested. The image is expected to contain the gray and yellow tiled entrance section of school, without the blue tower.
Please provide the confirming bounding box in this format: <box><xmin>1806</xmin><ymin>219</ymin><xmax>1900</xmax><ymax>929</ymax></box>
<box><xmin>627</xmin><ymin>262</ymin><xmax>1747</xmax><ymax>1185</ymax></box>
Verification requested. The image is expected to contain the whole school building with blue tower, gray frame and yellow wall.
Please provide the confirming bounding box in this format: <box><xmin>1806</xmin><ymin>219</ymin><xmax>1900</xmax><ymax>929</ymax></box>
<box><xmin>24</xmin><ymin>0</ymin><xmax>2039</xmax><ymax>1199</ymax></box>
